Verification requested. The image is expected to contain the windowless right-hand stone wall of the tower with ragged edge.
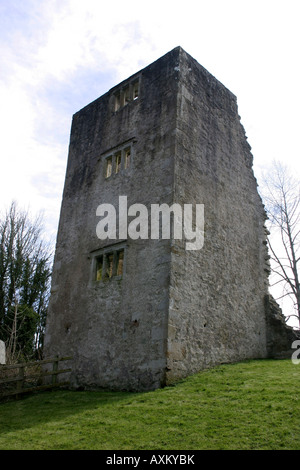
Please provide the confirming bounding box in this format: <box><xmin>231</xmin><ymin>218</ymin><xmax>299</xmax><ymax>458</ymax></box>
<box><xmin>168</xmin><ymin>51</ymin><xmax>267</xmax><ymax>379</ymax></box>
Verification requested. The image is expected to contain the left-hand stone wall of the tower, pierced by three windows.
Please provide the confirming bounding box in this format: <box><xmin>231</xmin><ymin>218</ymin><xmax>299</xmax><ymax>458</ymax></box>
<box><xmin>45</xmin><ymin>47</ymin><xmax>177</xmax><ymax>389</ymax></box>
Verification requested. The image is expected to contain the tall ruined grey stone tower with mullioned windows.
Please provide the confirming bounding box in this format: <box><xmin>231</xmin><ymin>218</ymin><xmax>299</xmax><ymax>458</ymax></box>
<box><xmin>45</xmin><ymin>47</ymin><xmax>296</xmax><ymax>390</ymax></box>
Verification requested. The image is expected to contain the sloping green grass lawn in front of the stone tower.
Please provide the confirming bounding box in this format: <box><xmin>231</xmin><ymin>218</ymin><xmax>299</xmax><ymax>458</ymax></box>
<box><xmin>0</xmin><ymin>360</ymin><xmax>300</xmax><ymax>450</ymax></box>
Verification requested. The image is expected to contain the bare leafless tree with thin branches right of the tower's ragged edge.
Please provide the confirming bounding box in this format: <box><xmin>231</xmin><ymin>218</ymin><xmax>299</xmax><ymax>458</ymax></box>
<box><xmin>262</xmin><ymin>162</ymin><xmax>300</xmax><ymax>326</ymax></box>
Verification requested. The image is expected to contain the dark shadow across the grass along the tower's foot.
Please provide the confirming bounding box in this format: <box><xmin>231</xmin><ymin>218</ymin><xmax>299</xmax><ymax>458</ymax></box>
<box><xmin>0</xmin><ymin>361</ymin><xmax>270</xmax><ymax>435</ymax></box>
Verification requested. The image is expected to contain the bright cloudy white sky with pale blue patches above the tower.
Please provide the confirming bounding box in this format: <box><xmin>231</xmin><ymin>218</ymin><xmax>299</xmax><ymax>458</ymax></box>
<box><xmin>0</xmin><ymin>0</ymin><xmax>300</xmax><ymax>320</ymax></box>
